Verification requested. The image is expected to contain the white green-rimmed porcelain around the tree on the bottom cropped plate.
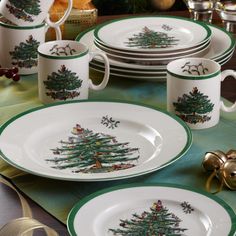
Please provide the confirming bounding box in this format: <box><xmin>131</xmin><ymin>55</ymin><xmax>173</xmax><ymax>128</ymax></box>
<box><xmin>67</xmin><ymin>184</ymin><xmax>233</xmax><ymax>236</ymax></box>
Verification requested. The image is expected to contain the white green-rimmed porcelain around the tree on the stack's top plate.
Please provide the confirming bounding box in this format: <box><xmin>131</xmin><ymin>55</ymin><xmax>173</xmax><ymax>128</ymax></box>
<box><xmin>94</xmin><ymin>16</ymin><xmax>211</xmax><ymax>52</ymax></box>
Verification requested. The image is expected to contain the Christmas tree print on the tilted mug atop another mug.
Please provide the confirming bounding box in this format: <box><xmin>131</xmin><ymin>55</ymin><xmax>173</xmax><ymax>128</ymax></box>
<box><xmin>6</xmin><ymin>0</ymin><xmax>41</xmax><ymax>22</ymax></box>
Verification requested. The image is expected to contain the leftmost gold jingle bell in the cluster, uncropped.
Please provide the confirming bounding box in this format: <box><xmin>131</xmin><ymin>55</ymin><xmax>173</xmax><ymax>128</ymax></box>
<box><xmin>202</xmin><ymin>150</ymin><xmax>227</xmax><ymax>171</ymax></box>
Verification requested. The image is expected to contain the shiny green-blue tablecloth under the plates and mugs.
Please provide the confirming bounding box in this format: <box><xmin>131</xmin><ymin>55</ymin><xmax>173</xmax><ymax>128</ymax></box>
<box><xmin>0</xmin><ymin>74</ymin><xmax>236</xmax><ymax>227</ymax></box>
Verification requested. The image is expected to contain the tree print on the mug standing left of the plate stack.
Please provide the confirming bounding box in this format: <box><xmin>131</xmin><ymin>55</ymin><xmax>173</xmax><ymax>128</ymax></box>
<box><xmin>43</xmin><ymin>65</ymin><xmax>82</xmax><ymax>100</ymax></box>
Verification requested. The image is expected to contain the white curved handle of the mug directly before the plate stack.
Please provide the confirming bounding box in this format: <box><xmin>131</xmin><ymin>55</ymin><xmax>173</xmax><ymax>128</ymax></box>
<box><xmin>89</xmin><ymin>52</ymin><xmax>110</xmax><ymax>90</ymax></box>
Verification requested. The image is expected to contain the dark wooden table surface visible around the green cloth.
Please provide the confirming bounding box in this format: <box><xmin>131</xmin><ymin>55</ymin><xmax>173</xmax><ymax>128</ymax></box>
<box><xmin>0</xmin><ymin>11</ymin><xmax>236</xmax><ymax>236</ymax></box>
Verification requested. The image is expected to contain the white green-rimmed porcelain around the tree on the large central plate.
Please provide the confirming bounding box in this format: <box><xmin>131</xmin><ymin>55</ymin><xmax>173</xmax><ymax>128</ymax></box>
<box><xmin>0</xmin><ymin>101</ymin><xmax>192</xmax><ymax>181</ymax></box>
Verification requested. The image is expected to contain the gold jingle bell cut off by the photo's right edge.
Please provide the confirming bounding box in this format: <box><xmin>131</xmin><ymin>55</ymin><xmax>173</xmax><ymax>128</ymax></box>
<box><xmin>220</xmin><ymin>159</ymin><xmax>236</xmax><ymax>190</ymax></box>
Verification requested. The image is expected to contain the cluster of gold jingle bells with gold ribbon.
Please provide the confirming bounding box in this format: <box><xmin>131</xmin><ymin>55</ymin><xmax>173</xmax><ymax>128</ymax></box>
<box><xmin>202</xmin><ymin>150</ymin><xmax>236</xmax><ymax>193</ymax></box>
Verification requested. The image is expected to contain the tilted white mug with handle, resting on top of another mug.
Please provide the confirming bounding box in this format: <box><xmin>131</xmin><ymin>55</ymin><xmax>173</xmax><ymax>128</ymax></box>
<box><xmin>0</xmin><ymin>0</ymin><xmax>73</xmax><ymax>27</ymax></box>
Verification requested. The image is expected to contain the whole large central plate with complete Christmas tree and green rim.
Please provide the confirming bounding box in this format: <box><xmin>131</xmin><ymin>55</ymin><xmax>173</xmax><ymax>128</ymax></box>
<box><xmin>0</xmin><ymin>100</ymin><xmax>192</xmax><ymax>181</ymax></box>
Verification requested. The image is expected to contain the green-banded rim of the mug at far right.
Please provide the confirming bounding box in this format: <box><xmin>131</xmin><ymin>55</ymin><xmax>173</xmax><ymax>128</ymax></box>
<box><xmin>166</xmin><ymin>57</ymin><xmax>221</xmax><ymax>80</ymax></box>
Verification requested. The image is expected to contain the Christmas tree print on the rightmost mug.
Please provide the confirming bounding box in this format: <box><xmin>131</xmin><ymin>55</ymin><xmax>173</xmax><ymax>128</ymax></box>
<box><xmin>173</xmin><ymin>87</ymin><xmax>214</xmax><ymax>124</ymax></box>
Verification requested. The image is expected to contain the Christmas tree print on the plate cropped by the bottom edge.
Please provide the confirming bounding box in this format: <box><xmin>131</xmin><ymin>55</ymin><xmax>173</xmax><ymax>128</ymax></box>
<box><xmin>109</xmin><ymin>200</ymin><xmax>187</xmax><ymax>236</ymax></box>
